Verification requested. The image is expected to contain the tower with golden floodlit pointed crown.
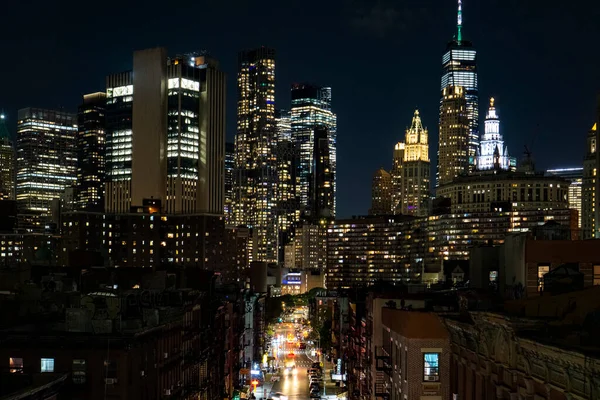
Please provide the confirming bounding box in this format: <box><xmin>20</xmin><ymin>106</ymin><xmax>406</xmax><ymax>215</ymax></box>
<box><xmin>402</xmin><ymin>110</ymin><xmax>430</xmax><ymax>216</ymax></box>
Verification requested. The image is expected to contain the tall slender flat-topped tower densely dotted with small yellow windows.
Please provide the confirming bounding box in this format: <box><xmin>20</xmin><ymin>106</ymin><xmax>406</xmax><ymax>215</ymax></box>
<box><xmin>233</xmin><ymin>47</ymin><xmax>278</xmax><ymax>262</ymax></box>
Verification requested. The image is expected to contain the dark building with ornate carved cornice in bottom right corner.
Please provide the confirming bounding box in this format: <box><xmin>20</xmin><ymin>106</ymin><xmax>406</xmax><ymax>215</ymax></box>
<box><xmin>444</xmin><ymin>287</ymin><xmax>600</xmax><ymax>400</ymax></box>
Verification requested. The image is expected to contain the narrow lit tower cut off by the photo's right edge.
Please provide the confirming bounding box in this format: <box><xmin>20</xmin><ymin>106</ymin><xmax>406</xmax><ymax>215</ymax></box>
<box><xmin>581</xmin><ymin>123</ymin><xmax>600</xmax><ymax>239</ymax></box>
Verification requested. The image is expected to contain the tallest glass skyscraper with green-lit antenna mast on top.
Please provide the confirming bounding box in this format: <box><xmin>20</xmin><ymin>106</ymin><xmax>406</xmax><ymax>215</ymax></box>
<box><xmin>438</xmin><ymin>0</ymin><xmax>479</xmax><ymax>180</ymax></box>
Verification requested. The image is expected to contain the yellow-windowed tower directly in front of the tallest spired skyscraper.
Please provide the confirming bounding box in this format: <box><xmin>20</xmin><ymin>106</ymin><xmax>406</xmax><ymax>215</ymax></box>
<box><xmin>437</xmin><ymin>86</ymin><xmax>470</xmax><ymax>186</ymax></box>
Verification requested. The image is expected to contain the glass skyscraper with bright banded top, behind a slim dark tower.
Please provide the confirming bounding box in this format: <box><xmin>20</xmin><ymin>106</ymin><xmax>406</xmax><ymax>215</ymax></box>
<box><xmin>291</xmin><ymin>84</ymin><xmax>337</xmax><ymax>216</ymax></box>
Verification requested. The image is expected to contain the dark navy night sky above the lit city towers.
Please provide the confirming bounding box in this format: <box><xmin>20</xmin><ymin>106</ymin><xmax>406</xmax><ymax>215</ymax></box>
<box><xmin>0</xmin><ymin>0</ymin><xmax>600</xmax><ymax>217</ymax></box>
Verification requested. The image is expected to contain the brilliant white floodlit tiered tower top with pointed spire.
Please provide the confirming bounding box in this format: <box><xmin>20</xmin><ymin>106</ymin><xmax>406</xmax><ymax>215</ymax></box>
<box><xmin>477</xmin><ymin>97</ymin><xmax>516</xmax><ymax>171</ymax></box>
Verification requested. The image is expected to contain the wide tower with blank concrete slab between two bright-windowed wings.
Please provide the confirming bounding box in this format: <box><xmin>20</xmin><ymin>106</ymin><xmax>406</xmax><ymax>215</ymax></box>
<box><xmin>105</xmin><ymin>48</ymin><xmax>225</xmax><ymax>214</ymax></box>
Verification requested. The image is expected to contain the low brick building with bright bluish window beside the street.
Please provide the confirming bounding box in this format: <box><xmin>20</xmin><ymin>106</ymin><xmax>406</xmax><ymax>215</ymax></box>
<box><xmin>375</xmin><ymin>308</ymin><xmax>451</xmax><ymax>400</ymax></box>
